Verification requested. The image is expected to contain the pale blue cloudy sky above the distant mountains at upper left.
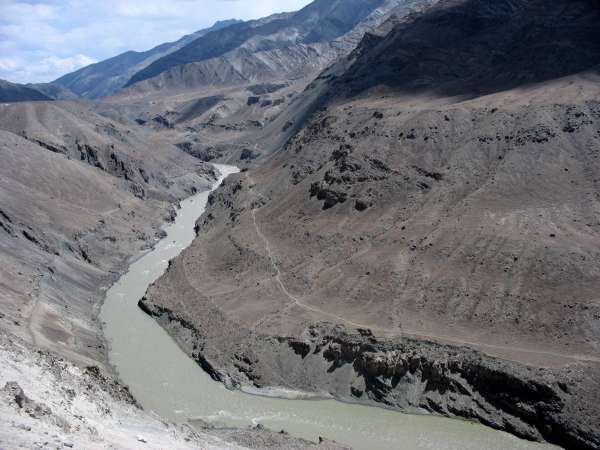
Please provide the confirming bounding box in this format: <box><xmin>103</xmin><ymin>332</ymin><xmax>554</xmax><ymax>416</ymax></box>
<box><xmin>0</xmin><ymin>0</ymin><xmax>310</xmax><ymax>83</ymax></box>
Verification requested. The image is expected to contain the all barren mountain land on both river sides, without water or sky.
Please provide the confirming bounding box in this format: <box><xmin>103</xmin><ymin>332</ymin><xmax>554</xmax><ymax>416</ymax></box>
<box><xmin>0</xmin><ymin>0</ymin><xmax>600</xmax><ymax>449</ymax></box>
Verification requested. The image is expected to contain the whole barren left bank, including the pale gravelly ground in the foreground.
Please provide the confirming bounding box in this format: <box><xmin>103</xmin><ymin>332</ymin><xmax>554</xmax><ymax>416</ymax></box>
<box><xmin>0</xmin><ymin>96</ymin><xmax>350</xmax><ymax>449</ymax></box>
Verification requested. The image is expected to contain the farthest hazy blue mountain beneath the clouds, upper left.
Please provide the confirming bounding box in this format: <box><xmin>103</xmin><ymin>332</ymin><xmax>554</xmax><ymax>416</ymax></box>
<box><xmin>53</xmin><ymin>19</ymin><xmax>241</xmax><ymax>99</ymax></box>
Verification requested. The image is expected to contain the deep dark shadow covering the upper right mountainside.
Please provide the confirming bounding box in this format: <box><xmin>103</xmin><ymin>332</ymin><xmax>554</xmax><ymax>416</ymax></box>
<box><xmin>335</xmin><ymin>0</ymin><xmax>600</xmax><ymax>98</ymax></box>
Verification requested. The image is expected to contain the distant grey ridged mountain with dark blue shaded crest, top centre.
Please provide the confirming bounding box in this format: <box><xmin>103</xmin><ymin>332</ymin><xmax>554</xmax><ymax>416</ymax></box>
<box><xmin>126</xmin><ymin>0</ymin><xmax>433</xmax><ymax>89</ymax></box>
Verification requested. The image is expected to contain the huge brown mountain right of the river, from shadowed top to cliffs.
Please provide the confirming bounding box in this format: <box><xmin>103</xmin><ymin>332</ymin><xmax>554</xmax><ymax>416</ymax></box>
<box><xmin>140</xmin><ymin>0</ymin><xmax>600</xmax><ymax>450</ymax></box>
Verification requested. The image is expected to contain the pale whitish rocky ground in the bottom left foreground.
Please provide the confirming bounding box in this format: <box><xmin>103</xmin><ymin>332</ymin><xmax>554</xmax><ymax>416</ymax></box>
<box><xmin>0</xmin><ymin>333</ymin><xmax>342</xmax><ymax>450</ymax></box>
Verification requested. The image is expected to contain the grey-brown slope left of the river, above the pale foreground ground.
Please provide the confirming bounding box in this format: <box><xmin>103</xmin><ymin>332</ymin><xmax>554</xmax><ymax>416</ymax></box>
<box><xmin>0</xmin><ymin>102</ymin><xmax>214</xmax><ymax>370</ymax></box>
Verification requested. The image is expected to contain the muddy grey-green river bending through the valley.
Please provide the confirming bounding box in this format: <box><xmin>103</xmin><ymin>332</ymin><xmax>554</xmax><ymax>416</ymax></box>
<box><xmin>101</xmin><ymin>165</ymin><xmax>555</xmax><ymax>450</ymax></box>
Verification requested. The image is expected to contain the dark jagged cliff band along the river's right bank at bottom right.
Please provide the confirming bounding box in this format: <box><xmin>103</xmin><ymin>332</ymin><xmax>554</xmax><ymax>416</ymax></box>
<box><xmin>140</xmin><ymin>296</ymin><xmax>600</xmax><ymax>450</ymax></box>
